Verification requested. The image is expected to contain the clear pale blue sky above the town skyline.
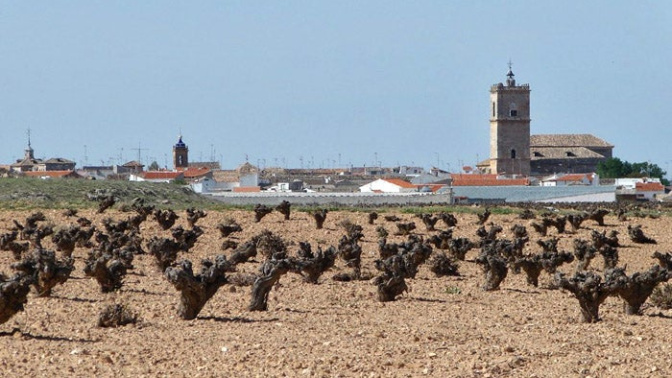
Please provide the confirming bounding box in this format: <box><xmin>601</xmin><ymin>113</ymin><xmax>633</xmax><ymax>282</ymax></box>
<box><xmin>0</xmin><ymin>0</ymin><xmax>672</xmax><ymax>175</ymax></box>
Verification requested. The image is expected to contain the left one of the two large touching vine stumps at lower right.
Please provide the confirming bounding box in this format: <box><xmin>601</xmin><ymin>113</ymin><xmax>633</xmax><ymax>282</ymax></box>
<box><xmin>555</xmin><ymin>271</ymin><xmax>623</xmax><ymax>323</ymax></box>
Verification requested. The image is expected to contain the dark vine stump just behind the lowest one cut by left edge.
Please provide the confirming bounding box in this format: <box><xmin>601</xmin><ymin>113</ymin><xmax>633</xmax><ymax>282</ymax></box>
<box><xmin>11</xmin><ymin>249</ymin><xmax>75</xmax><ymax>297</ymax></box>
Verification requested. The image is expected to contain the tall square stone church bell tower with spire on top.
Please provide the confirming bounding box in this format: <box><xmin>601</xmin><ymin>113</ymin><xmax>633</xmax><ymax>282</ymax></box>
<box><xmin>490</xmin><ymin>63</ymin><xmax>530</xmax><ymax>176</ymax></box>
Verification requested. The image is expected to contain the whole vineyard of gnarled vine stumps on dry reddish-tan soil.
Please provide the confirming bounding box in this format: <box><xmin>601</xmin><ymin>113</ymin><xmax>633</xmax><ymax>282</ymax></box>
<box><xmin>0</xmin><ymin>196</ymin><xmax>672</xmax><ymax>377</ymax></box>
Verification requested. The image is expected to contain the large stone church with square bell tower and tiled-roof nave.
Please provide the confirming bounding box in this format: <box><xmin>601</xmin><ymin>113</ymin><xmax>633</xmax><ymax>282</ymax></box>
<box><xmin>478</xmin><ymin>64</ymin><xmax>614</xmax><ymax>177</ymax></box>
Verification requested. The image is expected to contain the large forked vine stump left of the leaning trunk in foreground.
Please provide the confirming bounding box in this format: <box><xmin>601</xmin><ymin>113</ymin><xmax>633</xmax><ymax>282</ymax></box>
<box><xmin>165</xmin><ymin>255</ymin><xmax>234</xmax><ymax>320</ymax></box>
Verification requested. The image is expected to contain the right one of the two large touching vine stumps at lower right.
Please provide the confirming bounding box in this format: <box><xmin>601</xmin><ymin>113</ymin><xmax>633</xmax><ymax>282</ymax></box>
<box><xmin>606</xmin><ymin>265</ymin><xmax>672</xmax><ymax>315</ymax></box>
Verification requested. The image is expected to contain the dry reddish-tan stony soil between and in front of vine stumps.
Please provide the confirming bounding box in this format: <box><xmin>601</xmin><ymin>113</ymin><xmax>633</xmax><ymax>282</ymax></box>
<box><xmin>0</xmin><ymin>210</ymin><xmax>672</xmax><ymax>377</ymax></box>
